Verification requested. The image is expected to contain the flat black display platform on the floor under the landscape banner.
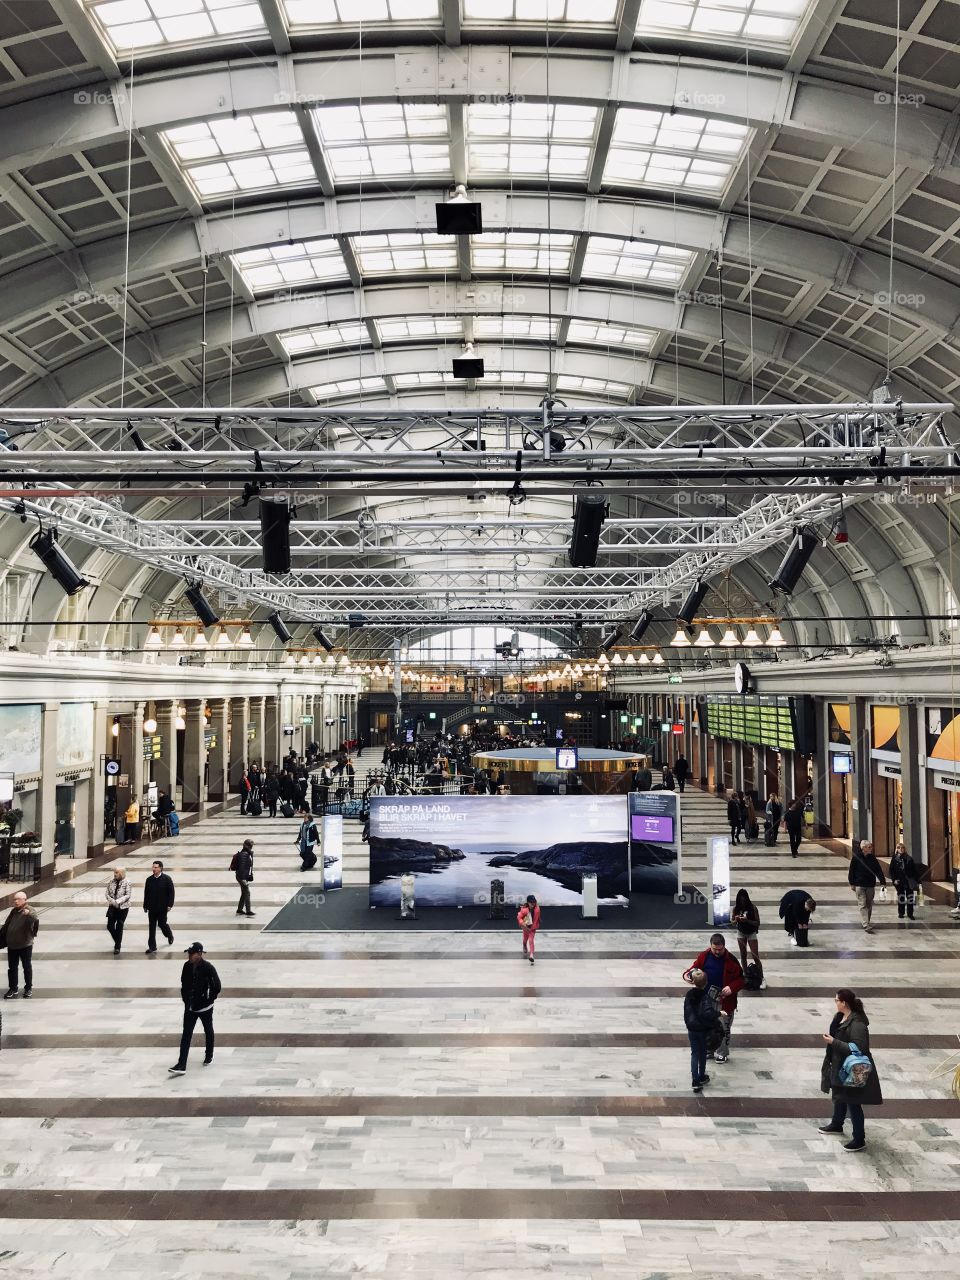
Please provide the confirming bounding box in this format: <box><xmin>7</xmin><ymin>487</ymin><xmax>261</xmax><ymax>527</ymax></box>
<box><xmin>264</xmin><ymin>883</ymin><xmax>708</xmax><ymax>933</ymax></box>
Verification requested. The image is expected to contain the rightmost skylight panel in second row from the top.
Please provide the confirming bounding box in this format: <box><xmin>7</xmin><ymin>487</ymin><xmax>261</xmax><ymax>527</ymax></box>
<box><xmin>603</xmin><ymin>108</ymin><xmax>750</xmax><ymax>192</ymax></box>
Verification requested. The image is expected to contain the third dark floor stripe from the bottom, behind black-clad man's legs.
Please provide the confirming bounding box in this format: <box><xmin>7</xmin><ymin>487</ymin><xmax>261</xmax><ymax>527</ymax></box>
<box><xmin>3</xmin><ymin>1019</ymin><xmax>956</xmax><ymax>1051</ymax></box>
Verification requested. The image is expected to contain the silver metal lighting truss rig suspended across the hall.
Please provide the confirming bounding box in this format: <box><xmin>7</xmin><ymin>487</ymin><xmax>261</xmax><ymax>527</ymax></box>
<box><xmin>0</xmin><ymin>404</ymin><xmax>960</xmax><ymax>625</ymax></box>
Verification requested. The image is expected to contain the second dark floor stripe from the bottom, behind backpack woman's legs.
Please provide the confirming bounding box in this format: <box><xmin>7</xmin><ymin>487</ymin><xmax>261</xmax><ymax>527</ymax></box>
<box><xmin>0</xmin><ymin>1095</ymin><xmax>960</xmax><ymax>1116</ymax></box>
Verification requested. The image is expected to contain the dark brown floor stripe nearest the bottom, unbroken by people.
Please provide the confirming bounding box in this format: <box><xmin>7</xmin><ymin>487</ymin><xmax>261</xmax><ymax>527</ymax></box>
<box><xmin>0</xmin><ymin>1187</ymin><xmax>960</xmax><ymax>1224</ymax></box>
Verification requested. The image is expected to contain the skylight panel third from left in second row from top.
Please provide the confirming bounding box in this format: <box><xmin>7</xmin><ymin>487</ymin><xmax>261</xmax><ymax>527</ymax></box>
<box><xmin>467</xmin><ymin>102</ymin><xmax>599</xmax><ymax>179</ymax></box>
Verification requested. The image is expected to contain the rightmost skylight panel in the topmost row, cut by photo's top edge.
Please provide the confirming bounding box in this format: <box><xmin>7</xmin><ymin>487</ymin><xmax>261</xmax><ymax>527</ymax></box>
<box><xmin>636</xmin><ymin>0</ymin><xmax>809</xmax><ymax>47</ymax></box>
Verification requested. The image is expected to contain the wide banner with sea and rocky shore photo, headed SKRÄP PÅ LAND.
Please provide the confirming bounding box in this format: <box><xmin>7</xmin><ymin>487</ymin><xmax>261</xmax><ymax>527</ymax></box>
<box><xmin>370</xmin><ymin>796</ymin><xmax>627</xmax><ymax>908</ymax></box>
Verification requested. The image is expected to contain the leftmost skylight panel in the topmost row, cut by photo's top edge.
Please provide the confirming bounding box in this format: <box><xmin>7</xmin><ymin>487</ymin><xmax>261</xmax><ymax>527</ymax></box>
<box><xmin>84</xmin><ymin>0</ymin><xmax>268</xmax><ymax>54</ymax></box>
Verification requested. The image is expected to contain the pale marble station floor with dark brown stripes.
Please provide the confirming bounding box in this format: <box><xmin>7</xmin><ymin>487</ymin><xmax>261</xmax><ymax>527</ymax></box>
<box><xmin>0</xmin><ymin>773</ymin><xmax>960</xmax><ymax>1280</ymax></box>
